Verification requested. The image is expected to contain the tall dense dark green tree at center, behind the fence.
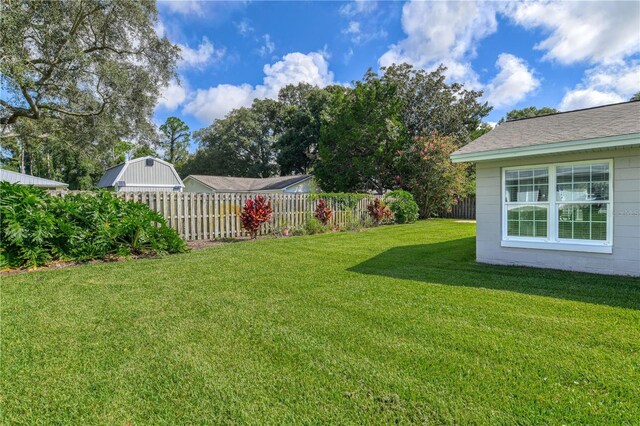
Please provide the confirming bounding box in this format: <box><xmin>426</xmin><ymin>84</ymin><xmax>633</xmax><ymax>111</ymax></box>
<box><xmin>314</xmin><ymin>71</ymin><xmax>407</xmax><ymax>193</ymax></box>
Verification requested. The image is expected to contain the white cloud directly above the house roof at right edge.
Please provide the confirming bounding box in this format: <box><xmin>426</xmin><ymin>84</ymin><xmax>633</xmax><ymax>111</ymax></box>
<box><xmin>559</xmin><ymin>61</ymin><xmax>640</xmax><ymax>111</ymax></box>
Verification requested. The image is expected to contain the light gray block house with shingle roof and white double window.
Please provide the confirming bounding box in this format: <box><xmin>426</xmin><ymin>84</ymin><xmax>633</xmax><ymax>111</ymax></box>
<box><xmin>451</xmin><ymin>102</ymin><xmax>640</xmax><ymax>276</ymax></box>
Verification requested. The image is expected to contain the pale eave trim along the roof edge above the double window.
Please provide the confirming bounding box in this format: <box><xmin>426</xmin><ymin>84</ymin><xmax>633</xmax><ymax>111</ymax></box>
<box><xmin>451</xmin><ymin>133</ymin><xmax>640</xmax><ymax>163</ymax></box>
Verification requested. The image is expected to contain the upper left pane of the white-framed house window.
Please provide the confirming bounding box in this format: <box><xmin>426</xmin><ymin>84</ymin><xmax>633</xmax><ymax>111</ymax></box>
<box><xmin>505</xmin><ymin>167</ymin><xmax>549</xmax><ymax>203</ymax></box>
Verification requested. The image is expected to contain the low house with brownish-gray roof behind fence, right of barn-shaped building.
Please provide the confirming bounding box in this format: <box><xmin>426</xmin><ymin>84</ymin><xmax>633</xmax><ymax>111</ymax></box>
<box><xmin>184</xmin><ymin>175</ymin><xmax>315</xmax><ymax>194</ymax></box>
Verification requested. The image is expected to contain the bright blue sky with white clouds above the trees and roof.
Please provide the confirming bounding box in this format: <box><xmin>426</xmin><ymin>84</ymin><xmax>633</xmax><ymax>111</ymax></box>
<box><xmin>155</xmin><ymin>0</ymin><xmax>640</xmax><ymax>139</ymax></box>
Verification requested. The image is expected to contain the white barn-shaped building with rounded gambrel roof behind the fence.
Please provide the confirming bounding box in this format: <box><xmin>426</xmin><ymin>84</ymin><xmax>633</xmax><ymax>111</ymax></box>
<box><xmin>98</xmin><ymin>157</ymin><xmax>184</xmax><ymax>192</ymax></box>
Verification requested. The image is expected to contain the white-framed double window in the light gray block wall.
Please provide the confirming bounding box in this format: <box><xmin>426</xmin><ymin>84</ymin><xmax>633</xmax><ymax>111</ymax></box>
<box><xmin>502</xmin><ymin>160</ymin><xmax>613</xmax><ymax>253</ymax></box>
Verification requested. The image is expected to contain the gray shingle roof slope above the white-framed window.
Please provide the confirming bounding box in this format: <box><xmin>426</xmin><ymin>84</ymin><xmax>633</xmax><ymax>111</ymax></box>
<box><xmin>453</xmin><ymin>101</ymin><xmax>640</xmax><ymax>155</ymax></box>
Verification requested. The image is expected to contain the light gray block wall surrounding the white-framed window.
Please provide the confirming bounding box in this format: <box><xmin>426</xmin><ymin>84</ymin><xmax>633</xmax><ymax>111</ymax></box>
<box><xmin>476</xmin><ymin>148</ymin><xmax>640</xmax><ymax>276</ymax></box>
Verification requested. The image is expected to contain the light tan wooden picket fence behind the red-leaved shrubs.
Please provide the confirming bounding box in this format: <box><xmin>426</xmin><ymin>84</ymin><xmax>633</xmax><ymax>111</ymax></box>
<box><xmin>55</xmin><ymin>191</ymin><xmax>370</xmax><ymax>241</ymax></box>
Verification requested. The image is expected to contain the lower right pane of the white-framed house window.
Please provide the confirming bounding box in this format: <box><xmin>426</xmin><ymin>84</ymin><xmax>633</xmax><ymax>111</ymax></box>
<box><xmin>558</xmin><ymin>203</ymin><xmax>607</xmax><ymax>241</ymax></box>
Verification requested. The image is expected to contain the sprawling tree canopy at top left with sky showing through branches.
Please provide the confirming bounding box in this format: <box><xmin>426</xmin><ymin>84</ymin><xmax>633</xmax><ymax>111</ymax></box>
<box><xmin>0</xmin><ymin>0</ymin><xmax>179</xmax><ymax>135</ymax></box>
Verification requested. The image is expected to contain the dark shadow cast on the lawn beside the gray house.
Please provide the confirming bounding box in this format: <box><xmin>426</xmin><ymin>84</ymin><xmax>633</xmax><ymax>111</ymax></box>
<box><xmin>348</xmin><ymin>237</ymin><xmax>640</xmax><ymax>309</ymax></box>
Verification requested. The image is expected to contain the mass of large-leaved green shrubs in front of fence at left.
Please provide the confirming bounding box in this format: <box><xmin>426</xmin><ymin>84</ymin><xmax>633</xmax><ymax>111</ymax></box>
<box><xmin>0</xmin><ymin>182</ymin><xmax>186</xmax><ymax>268</ymax></box>
